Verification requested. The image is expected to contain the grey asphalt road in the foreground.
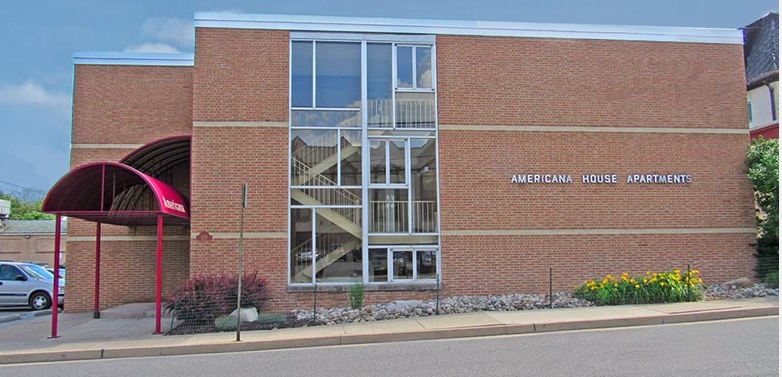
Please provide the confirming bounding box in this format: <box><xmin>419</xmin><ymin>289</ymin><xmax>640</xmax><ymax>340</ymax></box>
<box><xmin>0</xmin><ymin>317</ymin><xmax>779</xmax><ymax>377</ymax></box>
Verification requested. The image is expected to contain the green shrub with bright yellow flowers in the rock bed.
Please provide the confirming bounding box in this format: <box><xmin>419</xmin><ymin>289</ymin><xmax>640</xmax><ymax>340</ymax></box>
<box><xmin>573</xmin><ymin>269</ymin><xmax>703</xmax><ymax>305</ymax></box>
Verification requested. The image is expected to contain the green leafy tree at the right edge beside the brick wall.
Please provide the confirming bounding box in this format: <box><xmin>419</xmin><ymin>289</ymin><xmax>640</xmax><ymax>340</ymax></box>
<box><xmin>747</xmin><ymin>137</ymin><xmax>779</xmax><ymax>278</ymax></box>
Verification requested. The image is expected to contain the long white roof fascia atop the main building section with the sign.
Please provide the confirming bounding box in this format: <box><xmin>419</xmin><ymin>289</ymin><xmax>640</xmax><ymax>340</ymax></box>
<box><xmin>194</xmin><ymin>12</ymin><xmax>744</xmax><ymax>44</ymax></box>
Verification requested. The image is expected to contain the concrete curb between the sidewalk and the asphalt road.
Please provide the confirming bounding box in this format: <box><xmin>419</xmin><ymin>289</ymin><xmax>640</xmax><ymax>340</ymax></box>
<box><xmin>0</xmin><ymin>307</ymin><xmax>779</xmax><ymax>364</ymax></box>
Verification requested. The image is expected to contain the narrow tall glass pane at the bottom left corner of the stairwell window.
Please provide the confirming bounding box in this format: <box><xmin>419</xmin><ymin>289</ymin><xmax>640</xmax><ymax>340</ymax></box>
<box><xmin>290</xmin><ymin>208</ymin><xmax>312</xmax><ymax>283</ymax></box>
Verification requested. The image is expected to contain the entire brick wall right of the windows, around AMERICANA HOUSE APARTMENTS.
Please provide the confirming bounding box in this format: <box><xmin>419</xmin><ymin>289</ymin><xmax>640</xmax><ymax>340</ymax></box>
<box><xmin>437</xmin><ymin>36</ymin><xmax>755</xmax><ymax>294</ymax></box>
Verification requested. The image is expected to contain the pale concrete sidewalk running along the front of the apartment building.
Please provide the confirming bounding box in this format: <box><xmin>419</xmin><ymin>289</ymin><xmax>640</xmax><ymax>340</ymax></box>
<box><xmin>0</xmin><ymin>296</ymin><xmax>779</xmax><ymax>364</ymax></box>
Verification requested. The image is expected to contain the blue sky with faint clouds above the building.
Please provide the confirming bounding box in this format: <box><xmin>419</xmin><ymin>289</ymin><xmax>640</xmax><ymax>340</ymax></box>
<box><xmin>0</xmin><ymin>0</ymin><xmax>779</xmax><ymax>196</ymax></box>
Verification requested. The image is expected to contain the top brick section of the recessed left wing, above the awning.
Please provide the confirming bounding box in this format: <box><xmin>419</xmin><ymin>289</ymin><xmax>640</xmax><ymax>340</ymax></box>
<box><xmin>71</xmin><ymin>65</ymin><xmax>193</xmax><ymax>144</ymax></box>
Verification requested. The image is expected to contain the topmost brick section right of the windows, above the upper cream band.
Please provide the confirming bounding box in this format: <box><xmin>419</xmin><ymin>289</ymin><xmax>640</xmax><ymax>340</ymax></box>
<box><xmin>437</xmin><ymin>36</ymin><xmax>748</xmax><ymax>128</ymax></box>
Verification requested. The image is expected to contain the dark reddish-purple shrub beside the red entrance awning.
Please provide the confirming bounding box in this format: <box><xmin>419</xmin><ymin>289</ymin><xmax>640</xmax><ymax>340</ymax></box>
<box><xmin>165</xmin><ymin>272</ymin><xmax>269</xmax><ymax>323</ymax></box>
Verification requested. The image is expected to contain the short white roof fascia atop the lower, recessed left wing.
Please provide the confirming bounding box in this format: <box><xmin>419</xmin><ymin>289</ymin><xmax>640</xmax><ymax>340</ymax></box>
<box><xmin>73</xmin><ymin>52</ymin><xmax>194</xmax><ymax>67</ymax></box>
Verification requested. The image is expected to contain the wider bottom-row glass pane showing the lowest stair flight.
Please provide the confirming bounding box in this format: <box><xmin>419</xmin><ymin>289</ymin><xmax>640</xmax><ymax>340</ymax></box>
<box><xmin>315</xmin><ymin>208</ymin><xmax>362</xmax><ymax>282</ymax></box>
